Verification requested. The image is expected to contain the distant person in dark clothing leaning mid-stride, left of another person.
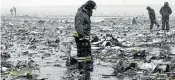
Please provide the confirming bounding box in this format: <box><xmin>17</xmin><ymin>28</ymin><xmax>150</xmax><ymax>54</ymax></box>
<box><xmin>146</xmin><ymin>6</ymin><xmax>160</xmax><ymax>30</ymax></box>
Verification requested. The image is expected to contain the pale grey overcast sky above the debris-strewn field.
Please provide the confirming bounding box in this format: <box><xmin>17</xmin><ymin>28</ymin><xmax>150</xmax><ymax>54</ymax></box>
<box><xmin>1</xmin><ymin>0</ymin><xmax>175</xmax><ymax>16</ymax></box>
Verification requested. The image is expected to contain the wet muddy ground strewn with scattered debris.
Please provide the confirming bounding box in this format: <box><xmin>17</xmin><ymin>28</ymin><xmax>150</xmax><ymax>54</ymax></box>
<box><xmin>1</xmin><ymin>15</ymin><xmax>175</xmax><ymax>80</ymax></box>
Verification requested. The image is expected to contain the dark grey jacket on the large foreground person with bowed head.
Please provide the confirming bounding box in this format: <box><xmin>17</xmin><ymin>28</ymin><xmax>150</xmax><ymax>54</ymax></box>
<box><xmin>75</xmin><ymin>5</ymin><xmax>92</xmax><ymax>37</ymax></box>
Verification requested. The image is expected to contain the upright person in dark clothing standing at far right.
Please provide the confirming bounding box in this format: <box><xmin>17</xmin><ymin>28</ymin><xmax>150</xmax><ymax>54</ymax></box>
<box><xmin>160</xmin><ymin>2</ymin><xmax>172</xmax><ymax>31</ymax></box>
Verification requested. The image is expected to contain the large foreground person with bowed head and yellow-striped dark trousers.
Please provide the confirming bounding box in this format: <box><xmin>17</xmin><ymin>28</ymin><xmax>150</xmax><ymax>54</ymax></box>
<box><xmin>74</xmin><ymin>0</ymin><xmax>96</xmax><ymax>74</ymax></box>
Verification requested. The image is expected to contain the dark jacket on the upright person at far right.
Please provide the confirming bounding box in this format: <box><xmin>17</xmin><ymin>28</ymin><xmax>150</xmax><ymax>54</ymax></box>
<box><xmin>160</xmin><ymin>5</ymin><xmax>172</xmax><ymax>17</ymax></box>
